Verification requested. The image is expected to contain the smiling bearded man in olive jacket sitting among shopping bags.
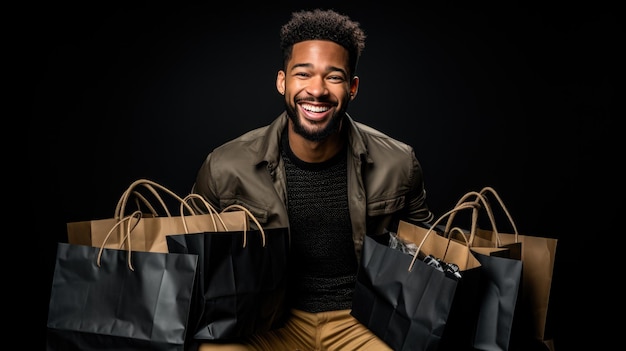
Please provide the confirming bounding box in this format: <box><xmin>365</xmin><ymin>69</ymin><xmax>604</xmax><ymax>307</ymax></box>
<box><xmin>193</xmin><ymin>9</ymin><xmax>433</xmax><ymax>351</ymax></box>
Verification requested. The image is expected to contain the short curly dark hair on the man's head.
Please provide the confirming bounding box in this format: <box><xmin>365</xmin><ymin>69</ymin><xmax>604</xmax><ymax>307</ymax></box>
<box><xmin>280</xmin><ymin>9</ymin><xmax>365</xmax><ymax>77</ymax></box>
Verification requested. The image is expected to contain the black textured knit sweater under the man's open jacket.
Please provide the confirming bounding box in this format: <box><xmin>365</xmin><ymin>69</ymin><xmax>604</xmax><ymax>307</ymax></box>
<box><xmin>282</xmin><ymin>135</ymin><xmax>357</xmax><ymax>313</ymax></box>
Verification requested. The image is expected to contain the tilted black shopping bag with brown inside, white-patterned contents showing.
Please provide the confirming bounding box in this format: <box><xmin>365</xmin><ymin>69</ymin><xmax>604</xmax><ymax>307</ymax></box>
<box><xmin>351</xmin><ymin>204</ymin><xmax>480</xmax><ymax>351</ymax></box>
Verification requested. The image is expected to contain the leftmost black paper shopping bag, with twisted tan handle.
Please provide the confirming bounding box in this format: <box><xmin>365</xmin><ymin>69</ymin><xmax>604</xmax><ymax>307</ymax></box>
<box><xmin>46</xmin><ymin>212</ymin><xmax>198</xmax><ymax>351</ymax></box>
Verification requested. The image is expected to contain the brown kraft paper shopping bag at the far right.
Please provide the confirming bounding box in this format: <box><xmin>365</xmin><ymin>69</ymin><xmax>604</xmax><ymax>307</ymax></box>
<box><xmin>468</xmin><ymin>187</ymin><xmax>558</xmax><ymax>350</ymax></box>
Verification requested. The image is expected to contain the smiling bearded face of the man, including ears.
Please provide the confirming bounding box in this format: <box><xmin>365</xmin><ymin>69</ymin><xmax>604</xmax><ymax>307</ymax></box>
<box><xmin>276</xmin><ymin>40</ymin><xmax>358</xmax><ymax>141</ymax></box>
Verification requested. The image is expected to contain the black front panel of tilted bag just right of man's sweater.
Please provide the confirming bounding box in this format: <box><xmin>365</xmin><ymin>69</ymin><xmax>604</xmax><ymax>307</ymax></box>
<box><xmin>351</xmin><ymin>236</ymin><xmax>457</xmax><ymax>351</ymax></box>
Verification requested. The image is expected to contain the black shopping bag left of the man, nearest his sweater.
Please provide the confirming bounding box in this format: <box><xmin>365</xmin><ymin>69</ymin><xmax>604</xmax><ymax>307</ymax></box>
<box><xmin>166</xmin><ymin>205</ymin><xmax>289</xmax><ymax>341</ymax></box>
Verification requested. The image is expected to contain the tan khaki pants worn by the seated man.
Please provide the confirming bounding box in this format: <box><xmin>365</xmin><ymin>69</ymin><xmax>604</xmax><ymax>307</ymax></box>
<box><xmin>198</xmin><ymin>310</ymin><xmax>391</xmax><ymax>351</ymax></box>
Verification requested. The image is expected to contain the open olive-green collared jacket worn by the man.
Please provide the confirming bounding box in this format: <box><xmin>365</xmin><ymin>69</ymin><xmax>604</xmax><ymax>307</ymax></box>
<box><xmin>192</xmin><ymin>112</ymin><xmax>433</xmax><ymax>258</ymax></box>
